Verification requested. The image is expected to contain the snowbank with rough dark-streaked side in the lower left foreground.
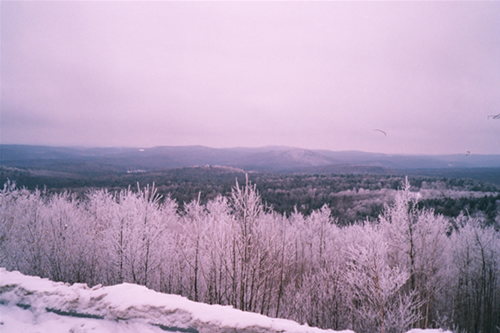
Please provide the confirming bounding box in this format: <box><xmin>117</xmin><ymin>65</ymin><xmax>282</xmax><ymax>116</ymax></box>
<box><xmin>0</xmin><ymin>268</ymin><xmax>452</xmax><ymax>333</ymax></box>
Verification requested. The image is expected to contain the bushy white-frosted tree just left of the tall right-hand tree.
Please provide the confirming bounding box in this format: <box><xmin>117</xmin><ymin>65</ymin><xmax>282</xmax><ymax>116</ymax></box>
<box><xmin>345</xmin><ymin>224</ymin><xmax>419</xmax><ymax>333</ymax></box>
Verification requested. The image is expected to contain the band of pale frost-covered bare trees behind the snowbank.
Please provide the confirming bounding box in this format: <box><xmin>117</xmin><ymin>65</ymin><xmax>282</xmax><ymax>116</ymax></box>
<box><xmin>0</xmin><ymin>175</ymin><xmax>500</xmax><ymax>333</ymax></box>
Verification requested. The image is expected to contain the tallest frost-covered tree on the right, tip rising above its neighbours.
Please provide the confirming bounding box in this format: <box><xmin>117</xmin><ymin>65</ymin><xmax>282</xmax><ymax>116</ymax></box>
<box><xmin>379</xmin><ymin>178</ymin><xmax>449</xmax><ymax>328</ymax></box>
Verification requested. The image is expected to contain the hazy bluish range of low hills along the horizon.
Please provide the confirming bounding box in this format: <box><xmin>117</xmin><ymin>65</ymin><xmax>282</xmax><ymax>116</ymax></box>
<box><xmin>0</xmin><ymin>145</ymin><xmax>500</xmax><ymax>173</ymax></box>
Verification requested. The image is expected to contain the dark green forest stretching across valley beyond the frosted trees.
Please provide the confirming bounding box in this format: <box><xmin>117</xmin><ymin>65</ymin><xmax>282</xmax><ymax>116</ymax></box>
<box><xmin>0</xmin><ymin>166</ymin><xmax>500</xmax><ymax>224</ymax></box>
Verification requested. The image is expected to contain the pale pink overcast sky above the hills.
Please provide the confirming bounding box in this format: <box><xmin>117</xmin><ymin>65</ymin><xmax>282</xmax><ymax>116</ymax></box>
<box><xmin>0</xmin><ymin>1</ymin><xmax>500</xmax><ymax>154</ymax></box>
